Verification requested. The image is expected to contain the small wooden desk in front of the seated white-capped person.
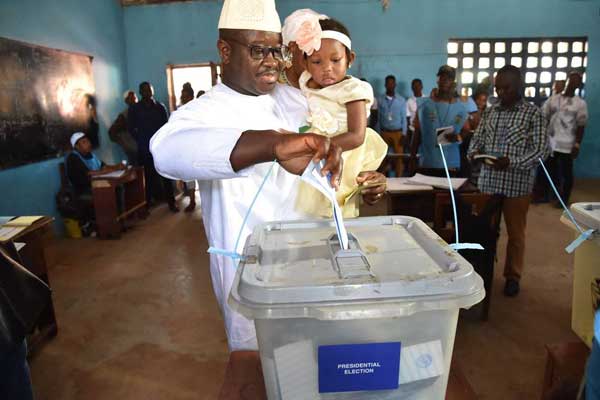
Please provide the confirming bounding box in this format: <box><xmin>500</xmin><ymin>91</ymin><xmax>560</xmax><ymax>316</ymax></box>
<box><xmin>92</xmin><ymin>167</ymin><xmax>146</xmax><ymax>239</ymax></box>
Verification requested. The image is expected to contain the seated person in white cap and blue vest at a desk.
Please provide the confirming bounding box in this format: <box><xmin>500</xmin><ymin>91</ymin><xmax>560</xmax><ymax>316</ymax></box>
<box><xmin>65</xmin><ymin>132</ymin><xmax>125</xmax><ymax>234</ymax></box>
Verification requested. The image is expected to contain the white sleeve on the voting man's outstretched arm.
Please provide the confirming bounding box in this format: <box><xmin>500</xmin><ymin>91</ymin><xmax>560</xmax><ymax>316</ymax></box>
<box><xmin>150</xmin><ymin>107</ymin><xmax>251</xmax><ymax>180</ymax></box>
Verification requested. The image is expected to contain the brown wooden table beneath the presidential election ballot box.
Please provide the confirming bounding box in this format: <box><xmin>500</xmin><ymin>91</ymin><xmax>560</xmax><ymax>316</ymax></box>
<box><xmin>219</xmin><ymin>351</ymin><xmax>476</xmax><ymax>400</ymax></box>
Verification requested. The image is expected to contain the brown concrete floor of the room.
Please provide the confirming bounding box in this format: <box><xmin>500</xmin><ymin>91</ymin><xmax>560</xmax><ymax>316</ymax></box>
<box><xmin>31</xmin><ymin>181</ymin><xmax>600</xmax><ymax>400</ymax></box>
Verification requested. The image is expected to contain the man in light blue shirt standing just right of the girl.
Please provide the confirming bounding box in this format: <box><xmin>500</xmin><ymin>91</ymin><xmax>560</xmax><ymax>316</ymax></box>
<box><xmin>377</xmin><ymin>75</ymin><xmax>407</xmax><ymax>176</ymax></box>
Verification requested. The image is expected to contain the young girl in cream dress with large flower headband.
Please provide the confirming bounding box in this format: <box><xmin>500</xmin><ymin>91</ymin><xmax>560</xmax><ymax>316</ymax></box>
<box><xmin>284</xmin><ymin>16</ymin><xmax>387</xmax><ymax>217</ymax></box>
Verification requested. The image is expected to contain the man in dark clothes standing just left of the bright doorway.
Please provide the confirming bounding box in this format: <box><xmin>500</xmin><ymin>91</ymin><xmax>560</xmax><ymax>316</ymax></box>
<box><xmin>127</xmin><ymin>82</ymin><xmax>179</xmax><ymax>212</ymax></box>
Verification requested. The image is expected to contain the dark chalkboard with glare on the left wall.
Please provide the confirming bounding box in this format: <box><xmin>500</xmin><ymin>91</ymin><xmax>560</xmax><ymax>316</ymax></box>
<box><xmin>0</xmin><ymin>38</ymin><xmax>98</xmax><ymax>169</ymax></box>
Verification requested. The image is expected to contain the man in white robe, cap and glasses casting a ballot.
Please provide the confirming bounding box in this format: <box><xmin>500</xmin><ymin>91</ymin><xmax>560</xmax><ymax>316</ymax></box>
<box><xmin>151</xmin><ymin>0</ymin><xmax>381</xmax><ymax>351</ymax></box>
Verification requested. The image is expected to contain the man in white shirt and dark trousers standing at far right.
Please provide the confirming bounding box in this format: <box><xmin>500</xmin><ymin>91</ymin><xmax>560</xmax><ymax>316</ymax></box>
<box><xmin>542</xmin><ymin>72</ymin><xmax>588</xmax><ymax>207</ymax></box>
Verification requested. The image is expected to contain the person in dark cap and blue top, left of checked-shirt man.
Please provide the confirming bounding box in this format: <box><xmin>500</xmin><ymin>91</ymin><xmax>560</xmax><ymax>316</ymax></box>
<box><xmin>410</xmin><ymin>65</ymin><xmax>468</xmax><ymax>176</ymax></box>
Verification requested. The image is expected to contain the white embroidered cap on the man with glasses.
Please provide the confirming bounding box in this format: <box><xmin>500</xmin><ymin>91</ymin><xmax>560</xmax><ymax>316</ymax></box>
<box><xmin>219</xmin><ymin>0</ymin><xmax>281</xmax><ymax>33</ymax></box>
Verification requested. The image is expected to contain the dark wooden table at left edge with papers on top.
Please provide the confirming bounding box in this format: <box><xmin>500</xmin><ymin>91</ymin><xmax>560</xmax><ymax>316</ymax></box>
<box><xmin>0</xmin><ymin>217</ymin><xmax>58</xmax><ymax>352</ymax></box>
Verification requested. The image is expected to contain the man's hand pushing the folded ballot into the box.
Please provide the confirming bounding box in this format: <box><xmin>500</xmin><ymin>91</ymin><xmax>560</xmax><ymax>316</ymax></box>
<box><xmin>273</xmin><ymin>133</ymin><xmax>342</xmax><ymax>190</ymax></box>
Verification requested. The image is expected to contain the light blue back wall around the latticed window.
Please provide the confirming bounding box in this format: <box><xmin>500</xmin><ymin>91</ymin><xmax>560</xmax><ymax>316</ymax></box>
<box><xmin>124</xmin><ymin>0</ymin><xmax>600</xmax><ymax>177</ymax></box>
